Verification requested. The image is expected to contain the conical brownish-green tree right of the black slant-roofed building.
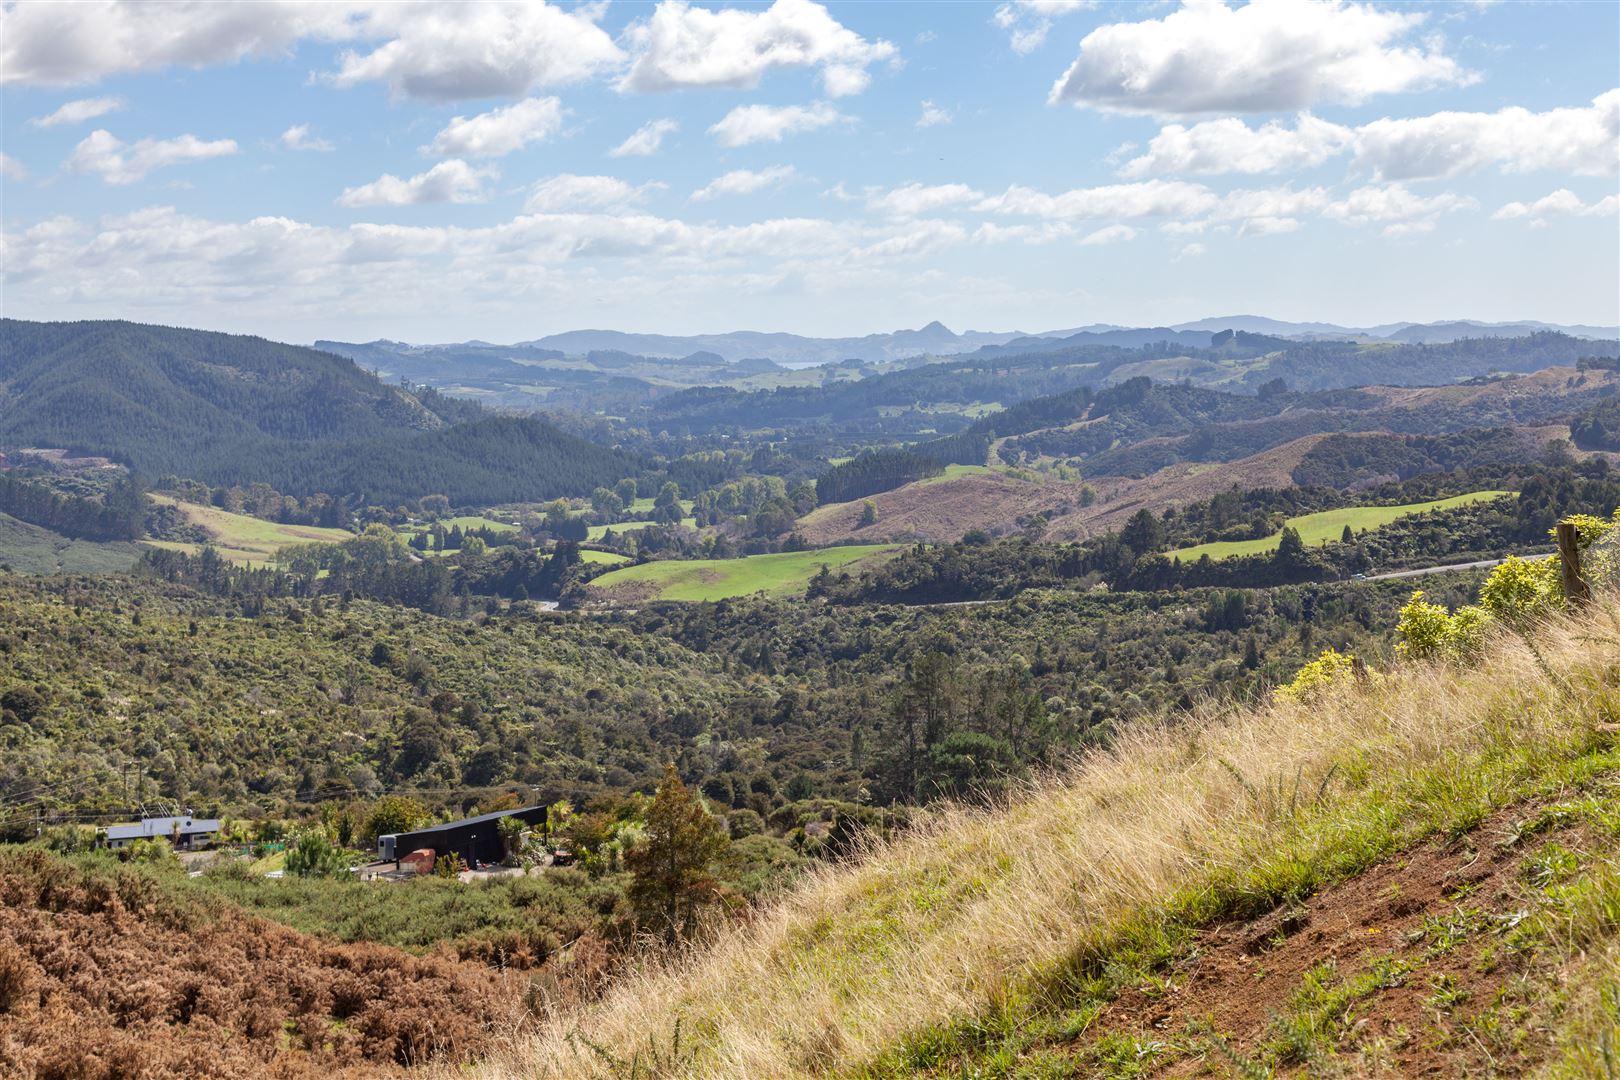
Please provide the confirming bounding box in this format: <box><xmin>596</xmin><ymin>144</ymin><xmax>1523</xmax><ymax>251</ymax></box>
<box><xmin>625</xmin><ymin>763</ymin><xmax>731</xmax><ymax>941</ymax></box>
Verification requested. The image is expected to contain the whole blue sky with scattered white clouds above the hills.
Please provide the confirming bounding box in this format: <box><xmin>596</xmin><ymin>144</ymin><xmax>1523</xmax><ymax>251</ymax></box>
<box><xmin>0</xmin><ymin>0</ymin><xmax>1620</xmax><ymax>342</ymax></box>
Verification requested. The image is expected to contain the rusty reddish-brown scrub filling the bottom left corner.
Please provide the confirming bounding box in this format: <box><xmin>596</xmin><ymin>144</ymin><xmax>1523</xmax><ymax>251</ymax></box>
<box><xmin>0</xmin><ymin>852</ymin><xmax>520</xmax><ymax>1080</ymax></box>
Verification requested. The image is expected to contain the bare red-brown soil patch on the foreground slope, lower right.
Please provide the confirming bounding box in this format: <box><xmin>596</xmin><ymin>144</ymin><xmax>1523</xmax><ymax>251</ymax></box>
<box><xmin>1076</xmin><ymin>808</ymin><xmax>1588</xmax><ymax>1077</ymax></box>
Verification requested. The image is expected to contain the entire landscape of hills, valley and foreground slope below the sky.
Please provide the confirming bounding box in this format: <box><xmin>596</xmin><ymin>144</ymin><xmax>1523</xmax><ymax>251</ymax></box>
<box><xmin>0</xmin><ymin>321</ymin><xmax>1620</xmax><ymax>1078</ymax></box>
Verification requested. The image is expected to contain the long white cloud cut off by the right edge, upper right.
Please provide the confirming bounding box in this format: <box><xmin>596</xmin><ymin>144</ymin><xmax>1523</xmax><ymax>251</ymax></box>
<box><xmin>1356</xmin><ymin>89</ymin><xmax>1620</xmax><ymax>180</ymax></box>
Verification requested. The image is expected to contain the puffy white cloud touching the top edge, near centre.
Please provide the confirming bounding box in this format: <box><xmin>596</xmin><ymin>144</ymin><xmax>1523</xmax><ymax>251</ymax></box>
<box><xmin>619</xmin><ymin>0</ymin><xmax>896</xmax><ymax>97</ymax></box>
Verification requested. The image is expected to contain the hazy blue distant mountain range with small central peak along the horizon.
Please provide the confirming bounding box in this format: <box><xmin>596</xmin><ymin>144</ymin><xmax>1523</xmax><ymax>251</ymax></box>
<box><xmin>316</xmin><ymin>316</ymin><xmax>1620</xmax><ymax>368</ymax></box>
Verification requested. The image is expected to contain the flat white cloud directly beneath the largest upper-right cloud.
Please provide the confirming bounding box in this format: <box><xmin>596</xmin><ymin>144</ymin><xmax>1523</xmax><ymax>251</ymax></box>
<box><xmin>1119</xmin><ymin>113</ymin><xmax>1354</xmax><ymax>176</ymax></box>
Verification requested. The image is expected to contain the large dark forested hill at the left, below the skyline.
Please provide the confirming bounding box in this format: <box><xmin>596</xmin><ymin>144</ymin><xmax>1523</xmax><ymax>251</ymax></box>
<box><xmin>0</xmin><ymin>319</ymin><xmax>633</xmax><ymax>504</ymax></box>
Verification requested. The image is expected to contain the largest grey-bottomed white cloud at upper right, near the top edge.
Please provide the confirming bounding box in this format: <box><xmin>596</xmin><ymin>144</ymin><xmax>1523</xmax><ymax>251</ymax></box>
<box><xmin>1050</xmin><ymin>0</ymin><xmax>1474</xmax><ymax>115</ymax></box>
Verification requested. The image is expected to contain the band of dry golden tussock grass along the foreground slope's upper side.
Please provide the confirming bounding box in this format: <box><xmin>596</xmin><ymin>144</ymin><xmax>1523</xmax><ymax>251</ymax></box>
<box><xmin>480</xmin><ymin>596</ymin><xmax>1620</xmax><ymax>1080</ymax></box>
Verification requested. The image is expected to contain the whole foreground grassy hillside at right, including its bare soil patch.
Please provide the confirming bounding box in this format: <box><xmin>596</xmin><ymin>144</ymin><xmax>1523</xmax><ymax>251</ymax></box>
<box><xmin>495</xmin><ymin>596</ymin><xmax>1620</xmax><ymax>1078</ymax></box>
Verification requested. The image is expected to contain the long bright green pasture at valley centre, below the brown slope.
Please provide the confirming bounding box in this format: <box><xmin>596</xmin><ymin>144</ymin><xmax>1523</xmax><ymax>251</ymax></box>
<box><xmin>590</xmin><ymin>544</ymin><xmax>896</xmax><ymax>601</ymax></box>
